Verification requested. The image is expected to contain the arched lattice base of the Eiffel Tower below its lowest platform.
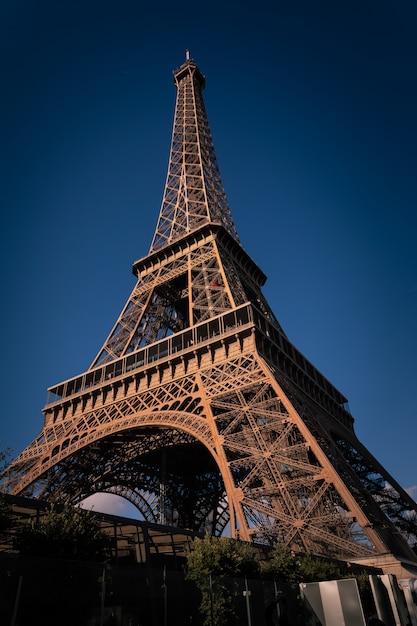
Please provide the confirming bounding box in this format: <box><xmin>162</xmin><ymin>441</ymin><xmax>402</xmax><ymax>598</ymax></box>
<box><xmin>6</xmin><ymin>326</ymin><xmax>416</xmax><ymax>558</ymax></box>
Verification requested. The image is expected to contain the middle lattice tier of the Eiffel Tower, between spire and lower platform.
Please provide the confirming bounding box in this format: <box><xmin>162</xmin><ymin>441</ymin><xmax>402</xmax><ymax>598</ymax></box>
<box><xmin>90</xmin><ymin>226</ymin><xmax>282</xmax><ymax>369</ymax></box>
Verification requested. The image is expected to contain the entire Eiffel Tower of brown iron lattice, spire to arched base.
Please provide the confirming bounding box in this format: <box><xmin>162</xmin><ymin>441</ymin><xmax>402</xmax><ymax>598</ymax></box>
<box><xmin>3</xmin><ymin>53</ymin><xmax>417</xmax><ymax>567</ymax></box>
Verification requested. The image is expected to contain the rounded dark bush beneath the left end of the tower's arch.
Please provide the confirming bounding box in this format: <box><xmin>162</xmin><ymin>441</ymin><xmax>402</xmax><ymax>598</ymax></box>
<box><xmin>14</xmin><ymin>504</ymin><xmax>109</xmax><ymax>561</ymax></box>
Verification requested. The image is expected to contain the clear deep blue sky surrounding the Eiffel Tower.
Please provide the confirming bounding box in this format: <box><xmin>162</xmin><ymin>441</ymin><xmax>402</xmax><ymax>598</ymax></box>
<box><xmin>0</xmin><ymin>0</ymin><xmax>417</xmax><ymax>512</ymax></box>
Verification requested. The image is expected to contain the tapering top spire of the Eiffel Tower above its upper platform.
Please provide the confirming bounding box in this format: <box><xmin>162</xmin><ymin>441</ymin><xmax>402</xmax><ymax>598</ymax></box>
<box><xmin>150</xmin><ymin>57</ymin><xmax>239</xmax><ymax>252</ymax></box>
